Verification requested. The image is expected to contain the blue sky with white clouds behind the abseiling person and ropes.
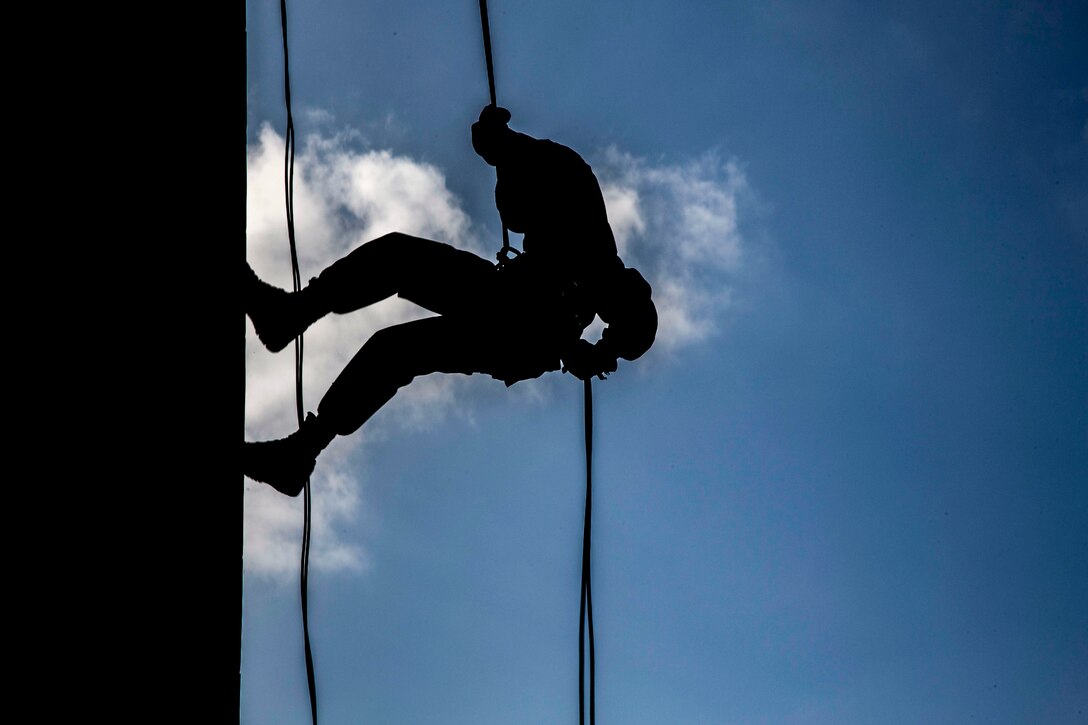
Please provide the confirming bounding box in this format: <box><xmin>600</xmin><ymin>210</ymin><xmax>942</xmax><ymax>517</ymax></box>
<box><xmin>242</xmin><ymin>0</ymin><xmax>1088</xmax><ymax>725</ymax></box>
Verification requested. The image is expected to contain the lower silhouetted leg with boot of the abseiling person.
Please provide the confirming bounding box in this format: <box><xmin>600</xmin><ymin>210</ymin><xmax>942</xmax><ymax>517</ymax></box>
<box><xmin>243</xmin><ymin>317</ymin><xmax>502</xmax><ymax>495</ymax></box>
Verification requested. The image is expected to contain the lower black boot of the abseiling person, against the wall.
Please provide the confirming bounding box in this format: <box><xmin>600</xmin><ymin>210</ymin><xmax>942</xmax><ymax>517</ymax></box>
<box><xmin>242</xmin><ymin>413</ymin><xmax>335</xmax><ymax>496</ymax></box>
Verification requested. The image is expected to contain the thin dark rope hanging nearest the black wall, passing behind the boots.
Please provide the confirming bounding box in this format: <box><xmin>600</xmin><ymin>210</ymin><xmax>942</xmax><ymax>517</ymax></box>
<box><xmin>280</xmin><ymin>0</ymin><xmax>318</xmax><ymax>725</ymax></box>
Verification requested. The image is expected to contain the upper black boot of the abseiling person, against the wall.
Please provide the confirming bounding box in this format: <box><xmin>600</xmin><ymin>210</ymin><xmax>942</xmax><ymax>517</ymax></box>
<box><xmin>245</xmin><ymin>262</ymin><xmax>329</xmax><ymax>353</ymax></box>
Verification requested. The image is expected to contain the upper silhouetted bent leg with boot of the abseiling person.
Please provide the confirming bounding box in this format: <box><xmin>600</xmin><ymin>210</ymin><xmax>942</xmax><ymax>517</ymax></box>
<box><xmin>245</xmin><ymin>232</ymin><xmax>494</xmax><ymax>352</ymax></box>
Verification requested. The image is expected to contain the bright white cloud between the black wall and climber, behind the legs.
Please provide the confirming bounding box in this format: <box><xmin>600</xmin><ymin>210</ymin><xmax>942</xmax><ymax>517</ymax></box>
<box><xmin>244</xmin><ymin>127</ymin><xmax>480</xmax><ymax>577</ymax></box>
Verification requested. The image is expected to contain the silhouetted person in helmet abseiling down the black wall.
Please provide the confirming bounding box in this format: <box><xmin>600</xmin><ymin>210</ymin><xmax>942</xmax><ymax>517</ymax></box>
<box><xmin>243</xmin><ymin>106</ymin><xmax>657</xmax><ymax>495</ymax></box>
